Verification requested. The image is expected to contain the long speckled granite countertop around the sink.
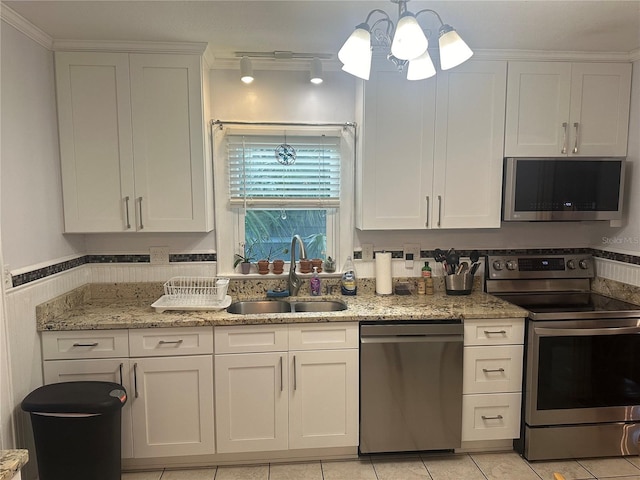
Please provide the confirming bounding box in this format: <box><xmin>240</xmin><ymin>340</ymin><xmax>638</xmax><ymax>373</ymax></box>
<box><xmin>36</xmin><ymin>285</ymin><xmax>527</xmax><ymax>331</ymax></box>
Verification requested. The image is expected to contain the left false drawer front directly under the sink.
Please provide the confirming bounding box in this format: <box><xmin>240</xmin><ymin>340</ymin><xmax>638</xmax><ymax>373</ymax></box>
<box><xmin>215</xmin><ymin>325</ymin><xmax>289</xmax><ymax>354</ymax></box>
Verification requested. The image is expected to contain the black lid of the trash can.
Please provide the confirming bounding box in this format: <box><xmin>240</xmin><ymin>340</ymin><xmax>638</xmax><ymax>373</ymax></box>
<box><xmin>22</xmin><ymin>381</ymin><xmax>127</xmax><ymax>413</ymax></box>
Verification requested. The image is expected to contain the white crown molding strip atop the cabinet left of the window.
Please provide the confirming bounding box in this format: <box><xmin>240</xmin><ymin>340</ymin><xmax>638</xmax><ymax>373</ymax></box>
<box><xmin>52</xmin><ymin>40</ymin><xmax>207</xmax><ymax>55</ymax></box>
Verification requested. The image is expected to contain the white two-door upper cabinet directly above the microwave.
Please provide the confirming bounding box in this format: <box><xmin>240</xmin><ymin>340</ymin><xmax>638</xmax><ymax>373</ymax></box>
<box><xmin>505</xmin><ymin>62</ymin><xmax>631</xmax><ymax>157</ymax></box>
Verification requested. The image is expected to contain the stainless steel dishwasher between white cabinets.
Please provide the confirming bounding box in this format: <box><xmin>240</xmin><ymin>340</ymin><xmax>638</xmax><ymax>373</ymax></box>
<box><xmin>360</xmin><ymin>320</ymin><xmax>463</xmax><ymax>453</ymax></box>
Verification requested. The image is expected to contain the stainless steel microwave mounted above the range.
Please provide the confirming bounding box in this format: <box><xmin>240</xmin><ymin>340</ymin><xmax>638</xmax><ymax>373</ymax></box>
<box><xmin>502</xmin><ymin>157</ymin><xmax>625</xmax><ymax>221</ymax></box>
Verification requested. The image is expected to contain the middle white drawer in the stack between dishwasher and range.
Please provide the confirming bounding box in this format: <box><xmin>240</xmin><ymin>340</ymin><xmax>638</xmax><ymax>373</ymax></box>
<box><xmin>462</xmin><ymin>345</ymin><xmax>524</xmax><ymax>393</ymax></box>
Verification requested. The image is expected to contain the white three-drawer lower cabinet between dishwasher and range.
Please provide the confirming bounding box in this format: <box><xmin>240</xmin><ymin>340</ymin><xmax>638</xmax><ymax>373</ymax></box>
<box><xmin>462</xmin><ymin>318</ymin><xmax>524</xmax><ymax>442</ymax></box>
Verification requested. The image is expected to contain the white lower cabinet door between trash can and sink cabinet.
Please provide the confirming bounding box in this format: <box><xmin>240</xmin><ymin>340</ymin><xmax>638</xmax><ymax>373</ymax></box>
<box><xmin>129</xmin><ymin>355</ymin><xmax>215</xmax><ymax>458</ymax></box>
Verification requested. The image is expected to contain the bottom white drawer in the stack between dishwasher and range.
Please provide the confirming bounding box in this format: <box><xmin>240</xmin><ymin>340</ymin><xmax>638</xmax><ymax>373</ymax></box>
<box><xmin>462</xmin><ymin>393</ymin><xmax>521</xmax><ymax>442</ymax></box>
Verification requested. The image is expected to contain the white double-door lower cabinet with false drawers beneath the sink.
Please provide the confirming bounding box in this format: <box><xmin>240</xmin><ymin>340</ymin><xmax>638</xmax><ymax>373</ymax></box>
<box><xmin>215</xmin><ymin>323</ymin><xmax>359</xmax><ymax>453</ymax></box>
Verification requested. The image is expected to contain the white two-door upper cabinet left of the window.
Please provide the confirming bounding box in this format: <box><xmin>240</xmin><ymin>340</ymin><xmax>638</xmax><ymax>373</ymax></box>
<box><xmin>56</xmin><ymin>52</ymin><xmax>213</xmax><ymax>233</ymax></box>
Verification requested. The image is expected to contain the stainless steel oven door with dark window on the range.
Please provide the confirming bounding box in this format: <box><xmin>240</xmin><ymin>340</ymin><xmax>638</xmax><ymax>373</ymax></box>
<box><xmin>525</xmin><ymin>319</ymin><xmax>640</xmax><ymax>426</ymax></box>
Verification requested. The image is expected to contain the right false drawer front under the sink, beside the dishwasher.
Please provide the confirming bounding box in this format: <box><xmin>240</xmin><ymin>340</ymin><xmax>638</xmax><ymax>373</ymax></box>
<box><xmin>289</xmin><ymin>322</ymin><xmax>358</xmax><ymax>350</ymax></box>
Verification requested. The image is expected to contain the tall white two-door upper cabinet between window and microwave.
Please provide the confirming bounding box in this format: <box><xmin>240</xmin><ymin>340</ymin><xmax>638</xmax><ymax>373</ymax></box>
<box><xmin>356</xmin><ymin>61</ymin><xmax>506</xmax><ymax>230</ymax></box>
